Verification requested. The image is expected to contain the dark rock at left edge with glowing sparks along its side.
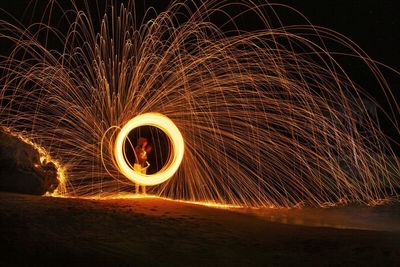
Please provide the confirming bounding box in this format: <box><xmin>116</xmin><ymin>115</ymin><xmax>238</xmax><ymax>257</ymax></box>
<box><xmin>0</xmin><ymin>131</ymin><xmax>59</xmax><ymax>195</ymax></box>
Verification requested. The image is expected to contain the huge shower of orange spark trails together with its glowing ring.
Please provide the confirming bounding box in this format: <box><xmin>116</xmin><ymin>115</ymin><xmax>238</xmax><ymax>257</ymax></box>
<box><xmin>0</xmin><ymin>0</ymin><xmax>400</xmax><ymax>207</ymax></box>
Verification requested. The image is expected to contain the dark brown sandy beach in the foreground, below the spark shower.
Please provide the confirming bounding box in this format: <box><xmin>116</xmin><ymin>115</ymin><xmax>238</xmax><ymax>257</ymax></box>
<box><xmin>0</xmin><ymin>193</ymin><xmax>400</xmax><ymax>266</ymax></box>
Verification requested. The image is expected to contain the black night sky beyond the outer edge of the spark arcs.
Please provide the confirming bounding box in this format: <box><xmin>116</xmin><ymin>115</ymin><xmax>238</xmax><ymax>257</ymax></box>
<box><xmin>0</xmin><ymin>0</ymin><xmax>400</xmax><ymax>148</ymax></box>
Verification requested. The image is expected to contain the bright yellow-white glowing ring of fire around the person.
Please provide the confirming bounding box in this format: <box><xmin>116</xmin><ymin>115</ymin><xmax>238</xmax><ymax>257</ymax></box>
<box><xmin>114</xmin><ymin>113</ymin><xmax>185</xmax><ymax>185</ymax></box>
